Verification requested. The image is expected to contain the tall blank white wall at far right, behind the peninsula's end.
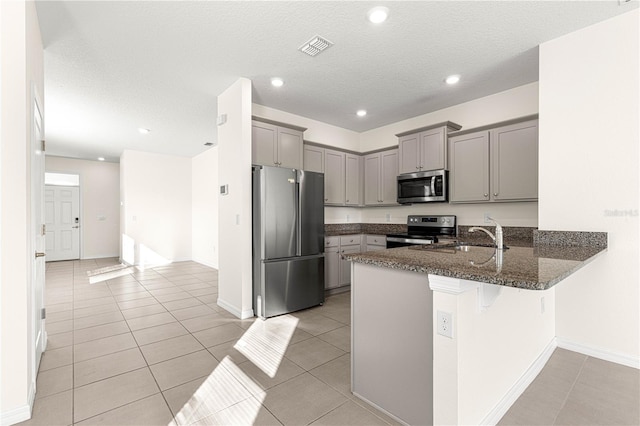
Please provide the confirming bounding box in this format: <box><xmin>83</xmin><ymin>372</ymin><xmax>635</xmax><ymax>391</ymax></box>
<box><xmin>539</xmin><ymin>10</ymin><xmax>640</xmax><ymax>366</ymax></box>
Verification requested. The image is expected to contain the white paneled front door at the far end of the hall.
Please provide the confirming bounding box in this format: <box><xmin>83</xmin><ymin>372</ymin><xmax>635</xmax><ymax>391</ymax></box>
<box><xmin>44</xmin><ymin>185</ymin><xmax>80</xmax><ymax>261</ymax></box>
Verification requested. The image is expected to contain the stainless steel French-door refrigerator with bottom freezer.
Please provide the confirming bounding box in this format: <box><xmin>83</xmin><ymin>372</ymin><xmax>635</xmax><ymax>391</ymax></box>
<box><xmin>252</xmin><ymin>166</ymin><xmax>324</xmax><ymax>318</ymax></box>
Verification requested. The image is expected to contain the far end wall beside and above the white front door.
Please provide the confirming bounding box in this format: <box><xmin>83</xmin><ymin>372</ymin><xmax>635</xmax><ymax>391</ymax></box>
<box><xmin>46</xmin><ymin>156</ymin><xmax>120</xmax><ymax>259</ymax></box>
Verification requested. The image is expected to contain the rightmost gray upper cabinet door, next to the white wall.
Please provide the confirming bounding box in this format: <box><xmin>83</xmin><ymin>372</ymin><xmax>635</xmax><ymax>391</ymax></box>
<box><xmin>489</xmin><ymin>120</ymin><xmax>538</xmax><ymax>201</ymax></box>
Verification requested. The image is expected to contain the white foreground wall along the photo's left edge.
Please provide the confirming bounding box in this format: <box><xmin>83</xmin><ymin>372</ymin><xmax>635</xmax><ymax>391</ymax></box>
<box><xmin>0</xmin><ymin>1</ymin><xmax>46</xmax><ymax>424</ymax></box>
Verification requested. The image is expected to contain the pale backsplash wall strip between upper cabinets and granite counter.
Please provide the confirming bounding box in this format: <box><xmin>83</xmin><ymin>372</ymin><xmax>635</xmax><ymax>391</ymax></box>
<box><xmin>324</xmin><ymin>202</ymin><xmax>538</xmax><ymax>227</ymax></box>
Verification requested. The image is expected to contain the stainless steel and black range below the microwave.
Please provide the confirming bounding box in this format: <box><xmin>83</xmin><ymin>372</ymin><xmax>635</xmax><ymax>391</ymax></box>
<box><xmin>387</xmin><ymin>215</ymin><xmax>456</xmax><ymax>248</ymax></box>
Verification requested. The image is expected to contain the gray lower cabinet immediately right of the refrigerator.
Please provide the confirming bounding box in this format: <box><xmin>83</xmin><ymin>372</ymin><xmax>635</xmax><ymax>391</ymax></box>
<box><xmin>324</xmin><ymin>235</ymin><xmax>362</xmax><ymax>290</ymax></box>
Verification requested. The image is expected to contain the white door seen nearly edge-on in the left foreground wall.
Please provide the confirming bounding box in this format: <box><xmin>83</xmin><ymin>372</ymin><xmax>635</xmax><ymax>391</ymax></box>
<box><xmin>31</xmin><ymin>96</ymin><xmax>47</xmax><ymax>370</ymax></box>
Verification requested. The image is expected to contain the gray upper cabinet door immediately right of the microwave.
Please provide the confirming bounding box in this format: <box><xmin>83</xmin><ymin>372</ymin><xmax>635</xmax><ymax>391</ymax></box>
<box><xmin>449</xmin><ymin>131</ymin><xmax>489</xmax><ymax>203</ymax></box>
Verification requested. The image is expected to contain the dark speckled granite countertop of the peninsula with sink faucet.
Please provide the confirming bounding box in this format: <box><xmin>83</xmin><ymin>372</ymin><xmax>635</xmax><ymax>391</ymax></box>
<box><xmin>344</xmin><ymin>238</ymin><xmax>607</xmax><ymax>290</ymax></box>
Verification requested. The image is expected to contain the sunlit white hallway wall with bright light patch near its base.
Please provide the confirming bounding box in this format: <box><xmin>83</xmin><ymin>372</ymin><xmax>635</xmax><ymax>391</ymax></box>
<box><xmin>120</xmin><ymin>150</ymin><xmax>191</xmax><ymax>265</ymax></box>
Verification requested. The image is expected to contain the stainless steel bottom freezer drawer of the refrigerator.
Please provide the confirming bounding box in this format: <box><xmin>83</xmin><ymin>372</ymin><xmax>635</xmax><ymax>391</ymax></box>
<box><xmin>254</xmin><ymin>255</ymin><xmax>324</xmax><ymax>318</ymax></box>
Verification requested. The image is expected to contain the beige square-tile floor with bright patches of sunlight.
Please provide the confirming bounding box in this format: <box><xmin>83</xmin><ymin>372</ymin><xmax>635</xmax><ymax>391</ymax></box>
<box><xmin>17</xmin><ymin>259</ymin><xmax>639</xmax><ymax>425</ymax></box>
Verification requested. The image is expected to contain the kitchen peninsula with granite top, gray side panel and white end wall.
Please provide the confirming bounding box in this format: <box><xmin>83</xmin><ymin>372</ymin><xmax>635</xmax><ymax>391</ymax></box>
<box><xmin>345</xmin><ymin>231</ymin><xmax>607</xmax><ymax>424</ymax></box>
